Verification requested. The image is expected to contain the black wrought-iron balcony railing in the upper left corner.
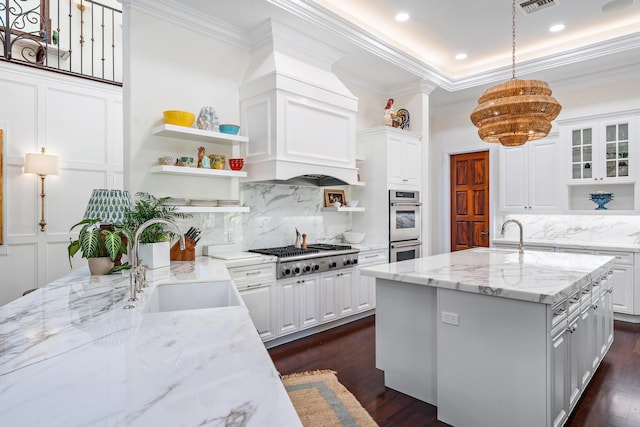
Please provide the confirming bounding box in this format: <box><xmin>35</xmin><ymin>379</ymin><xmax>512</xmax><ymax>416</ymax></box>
<box><xmin>0</xmin><ymin>0</ymin><xmax>122</xmax><ymax>85</ymax></box>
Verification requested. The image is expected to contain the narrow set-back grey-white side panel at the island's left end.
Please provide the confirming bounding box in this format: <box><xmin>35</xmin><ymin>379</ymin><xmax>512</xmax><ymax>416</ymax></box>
<box><xmin>376</xmin><ymin>279</ymin><xmax>438</xmax><ymax>405</ymax></box>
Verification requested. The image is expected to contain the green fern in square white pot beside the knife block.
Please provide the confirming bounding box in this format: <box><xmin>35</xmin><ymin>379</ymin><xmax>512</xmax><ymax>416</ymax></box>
<box><xmin>124</xmin><ymin>192</ymin><xmax>191</xmax><ymax>268</ymax></box>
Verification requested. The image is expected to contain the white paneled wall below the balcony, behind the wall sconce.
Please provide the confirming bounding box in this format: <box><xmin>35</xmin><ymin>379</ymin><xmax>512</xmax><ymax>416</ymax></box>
<box><xmin>0</xmin><ymin>63</ymin><xmax>123</xmax><ymax>305</ymax></box>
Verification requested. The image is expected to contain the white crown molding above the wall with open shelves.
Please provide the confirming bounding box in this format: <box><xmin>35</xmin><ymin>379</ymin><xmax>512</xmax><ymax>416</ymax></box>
<box><xmin>121</xmin><ymin>0</ymin><xmax>251</xmax><ymax>50</ymax></box>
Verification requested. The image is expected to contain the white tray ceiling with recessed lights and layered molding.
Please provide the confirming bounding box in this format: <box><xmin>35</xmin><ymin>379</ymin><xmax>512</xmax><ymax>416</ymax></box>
<box><xmin>175</xmin><ymin>0</ymin><xmax>640</xmax><ymax>102</ymax></box>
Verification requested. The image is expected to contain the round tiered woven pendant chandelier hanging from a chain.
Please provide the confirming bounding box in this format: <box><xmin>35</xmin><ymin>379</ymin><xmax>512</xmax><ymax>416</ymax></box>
<box><xmin>471</xmin><ymin>0</ymin><xmax>562</xmax><ymax>147</ymax></box>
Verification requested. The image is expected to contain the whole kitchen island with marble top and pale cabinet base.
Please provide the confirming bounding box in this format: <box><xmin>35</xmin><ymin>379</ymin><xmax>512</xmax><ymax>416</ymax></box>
<box><xmin>361</xmin><ymin>248</ymin><xmax>613</xmax><ymax>427</ymax></box>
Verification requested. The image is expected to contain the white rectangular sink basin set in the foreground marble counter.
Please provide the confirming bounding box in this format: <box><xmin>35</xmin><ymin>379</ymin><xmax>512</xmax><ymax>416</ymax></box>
<box><xmin>146</xmin><ymin>282</ymin><xmax>242</xmax><ymax>313</ymax></box>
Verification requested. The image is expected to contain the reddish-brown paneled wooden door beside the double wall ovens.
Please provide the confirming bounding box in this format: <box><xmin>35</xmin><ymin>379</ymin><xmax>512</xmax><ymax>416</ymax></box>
<box><xmin>450</xmin><ymin>151</ymin><xmax>489</xmax><ymax>251</ymax></box>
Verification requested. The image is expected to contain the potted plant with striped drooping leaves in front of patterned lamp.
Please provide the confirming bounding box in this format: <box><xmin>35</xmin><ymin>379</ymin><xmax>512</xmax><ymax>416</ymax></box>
<box><xmin>67</xmin><ymin>219</ymin><xmax>133</xmax><ymax>276</ymax></box>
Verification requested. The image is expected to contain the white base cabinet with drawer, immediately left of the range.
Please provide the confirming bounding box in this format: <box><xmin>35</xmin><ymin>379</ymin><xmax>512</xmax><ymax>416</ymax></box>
<box><xmin>228</xmin><ymin>263</ymin><xmax>276</xmax><ymax>341</ymax></box>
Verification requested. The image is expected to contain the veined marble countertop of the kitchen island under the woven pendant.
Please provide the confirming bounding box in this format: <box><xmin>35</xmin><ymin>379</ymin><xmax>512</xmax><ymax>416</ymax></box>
<box><xmin>360</xmin><ymin>248</ymin><xmax>614</xmax><ymax>304</ymax></box>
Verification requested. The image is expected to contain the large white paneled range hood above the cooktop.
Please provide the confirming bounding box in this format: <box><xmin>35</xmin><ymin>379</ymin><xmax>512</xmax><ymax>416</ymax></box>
<box><xmin>240</xmin><ymin>20</ymin><xmax>358</xmax><ymax>186</ymax></box>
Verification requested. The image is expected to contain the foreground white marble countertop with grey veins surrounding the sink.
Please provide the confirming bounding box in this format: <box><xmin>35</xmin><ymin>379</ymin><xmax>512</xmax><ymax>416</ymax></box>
<box><xmin>0</xmin><ymin>257</ymin><xmax>301</xmax><ymax>427</ymax></box>
